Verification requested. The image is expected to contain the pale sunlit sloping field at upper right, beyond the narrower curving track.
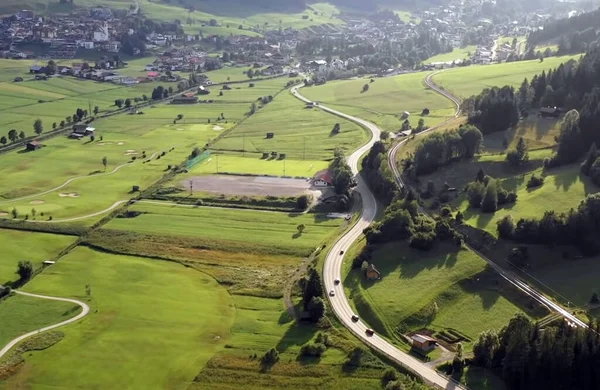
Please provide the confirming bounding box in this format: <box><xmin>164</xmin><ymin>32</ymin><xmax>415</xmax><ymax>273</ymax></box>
<box><xmin>434</xmin><ymin>55</ymin><xmax>580</xmax><ymax>98</ymax></box>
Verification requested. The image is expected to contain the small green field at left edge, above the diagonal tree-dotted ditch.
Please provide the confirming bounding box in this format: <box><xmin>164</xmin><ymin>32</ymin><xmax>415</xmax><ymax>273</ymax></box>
<box><xmin>0</xmin><ymin>229</ymin><xmax>75</xmax><ymax>284</ymax></box>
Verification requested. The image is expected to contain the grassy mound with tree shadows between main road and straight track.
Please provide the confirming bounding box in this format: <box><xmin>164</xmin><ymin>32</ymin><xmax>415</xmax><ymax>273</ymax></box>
<box><xmin>344</xmin><ymin>243</ymin><xmax>536</xmax><ymax>349</ymax></box>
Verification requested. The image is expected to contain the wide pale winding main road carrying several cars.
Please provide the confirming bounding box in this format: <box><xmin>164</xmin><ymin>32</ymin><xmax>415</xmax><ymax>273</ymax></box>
<box><xmin>291</xmin><ymin>87</ymin><xmax>465</xmax><ymax>389</ymax></box>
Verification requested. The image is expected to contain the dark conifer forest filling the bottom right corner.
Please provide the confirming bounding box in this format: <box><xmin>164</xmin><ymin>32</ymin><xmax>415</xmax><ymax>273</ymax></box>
<box><xmin>472</xmin><ymin>314</ymin><xmax>600</xmax><ymax>390</ymax></box>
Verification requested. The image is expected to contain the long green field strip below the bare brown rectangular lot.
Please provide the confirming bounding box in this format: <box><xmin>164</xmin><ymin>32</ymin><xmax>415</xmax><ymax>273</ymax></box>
<box><xmin>106</xmin><ymin>203</ymin><xmax>343</xmax><ymax>255</ymax></box>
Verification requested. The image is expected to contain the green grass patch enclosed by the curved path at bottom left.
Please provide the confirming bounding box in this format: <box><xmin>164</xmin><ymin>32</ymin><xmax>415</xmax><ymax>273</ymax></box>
<box><xmin>0</xmin><ymin>294</ymin><xmax>81</xmax><ymax>348</ymax></box>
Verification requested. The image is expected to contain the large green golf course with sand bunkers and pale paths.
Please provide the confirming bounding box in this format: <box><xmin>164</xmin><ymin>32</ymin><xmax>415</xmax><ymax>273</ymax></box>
<box><xmin>0</xmin><ymin>100</ymin><xmax>247</xmax><ymax>219</ymax></box>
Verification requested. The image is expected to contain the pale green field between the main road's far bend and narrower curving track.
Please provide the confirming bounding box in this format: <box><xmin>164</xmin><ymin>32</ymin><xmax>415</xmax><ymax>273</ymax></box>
<box><xmin>302</xmin><ymin>73</ymin><xmax>454</xmax><ymax>131</ymax></box>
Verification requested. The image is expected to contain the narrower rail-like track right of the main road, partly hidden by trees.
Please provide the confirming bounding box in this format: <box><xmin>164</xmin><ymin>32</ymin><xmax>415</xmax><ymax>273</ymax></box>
<box><xmin>388</xmin><ymin>71</ymin><xmax>588</xmax><ymax>328</ymax></box>
